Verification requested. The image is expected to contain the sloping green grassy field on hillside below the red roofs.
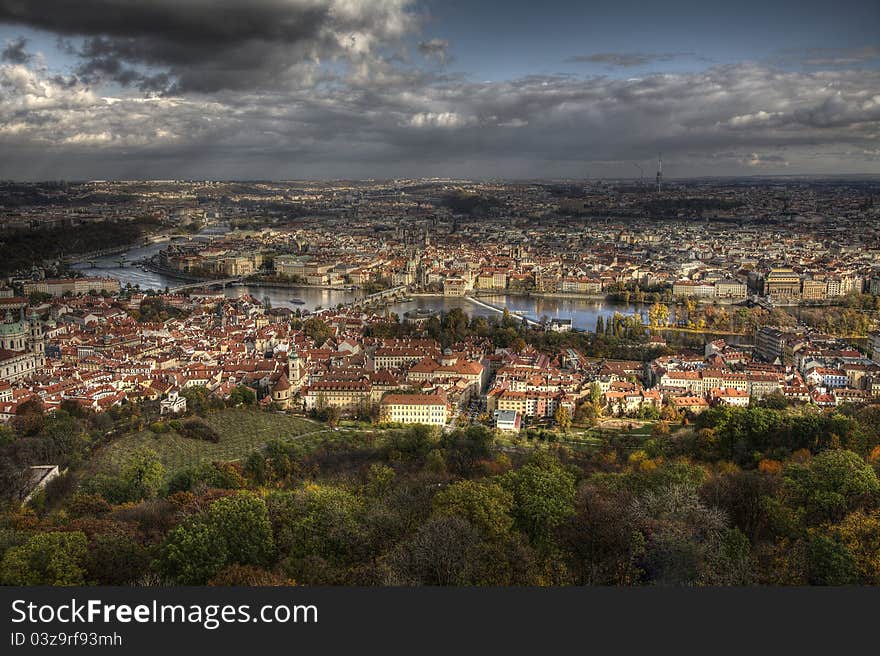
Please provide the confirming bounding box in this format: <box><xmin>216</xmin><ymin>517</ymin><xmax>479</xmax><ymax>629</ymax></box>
<box><xmin>87</xmin><ymin>408</ymin><xmax>329</xmax><ymax>476</ymax></box>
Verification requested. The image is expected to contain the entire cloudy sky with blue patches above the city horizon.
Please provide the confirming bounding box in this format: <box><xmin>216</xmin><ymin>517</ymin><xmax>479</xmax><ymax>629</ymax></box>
<box><xmin>0</xmin><ymin>0</ymin><xmax>880</xmax><ymax>179</ymax></box>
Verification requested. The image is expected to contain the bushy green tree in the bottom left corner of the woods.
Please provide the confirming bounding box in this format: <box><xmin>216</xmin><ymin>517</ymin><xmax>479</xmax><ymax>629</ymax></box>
<box><xmin>0</xmin><ymin>531</ymin><xmax>88</xmax><ymax>585</ymax></box>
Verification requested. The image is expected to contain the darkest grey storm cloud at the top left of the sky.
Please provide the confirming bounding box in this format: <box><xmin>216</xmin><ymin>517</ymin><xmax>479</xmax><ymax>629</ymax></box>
<box><xmin>0</xmin><ymin>0</ymin><xmax>414</xmax><ymax>93</ymax></box>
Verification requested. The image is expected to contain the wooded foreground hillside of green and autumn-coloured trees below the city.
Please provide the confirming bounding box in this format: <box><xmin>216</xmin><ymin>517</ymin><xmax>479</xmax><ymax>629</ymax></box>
<box><xmin>10</xmin><ymin>398</ymin><xmax>880</xmax><ymax>585</ymax></box>
